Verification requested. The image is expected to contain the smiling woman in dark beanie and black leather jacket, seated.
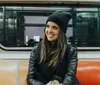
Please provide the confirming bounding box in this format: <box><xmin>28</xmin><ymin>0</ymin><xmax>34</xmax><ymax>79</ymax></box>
<box><xmin>27</xmin><ymin>11</ymin><xmax>78</xmax><ymax>85</ymax></box>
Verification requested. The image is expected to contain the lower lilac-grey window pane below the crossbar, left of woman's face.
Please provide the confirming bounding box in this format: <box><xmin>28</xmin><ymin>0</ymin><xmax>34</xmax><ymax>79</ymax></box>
<box><xmin>24</xmin><ymin>27</ymin><xmax>44</xmax><ymax>46</ymax></box>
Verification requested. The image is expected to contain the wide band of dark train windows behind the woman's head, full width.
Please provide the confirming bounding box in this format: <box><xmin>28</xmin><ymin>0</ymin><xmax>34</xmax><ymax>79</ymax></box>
<box><xmin>0</xmin><ymin>5</ymin><xmax>100</xmax><ymax>47</ymax></box>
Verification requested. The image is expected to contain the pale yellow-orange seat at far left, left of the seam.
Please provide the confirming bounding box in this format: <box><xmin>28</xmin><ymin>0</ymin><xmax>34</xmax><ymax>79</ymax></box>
<box><xmin>0</xmin><ymin>62</ymin><xmax>17</xmax><ymax>85</ymax></box>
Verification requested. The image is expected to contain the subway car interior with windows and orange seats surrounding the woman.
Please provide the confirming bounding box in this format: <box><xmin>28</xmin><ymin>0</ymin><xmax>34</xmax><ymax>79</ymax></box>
<box><xmin>0</xmin><ymin>0</ymin><xmax>100</xmax><ymax>85</ymax></box>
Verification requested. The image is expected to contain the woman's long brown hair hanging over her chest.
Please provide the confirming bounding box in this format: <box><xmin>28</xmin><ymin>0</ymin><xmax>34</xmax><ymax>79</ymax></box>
<box><xmin>40</xmin><ymin>30</ymin><xmax>67</xmax><ymax>67</ymax></box>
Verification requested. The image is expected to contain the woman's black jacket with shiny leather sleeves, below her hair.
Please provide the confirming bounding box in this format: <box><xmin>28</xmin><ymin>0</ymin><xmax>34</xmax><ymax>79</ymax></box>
<box><xmin>27</xmin><ymin>44</ymin><xmax>78</xmax><ymax>85</ymax></box>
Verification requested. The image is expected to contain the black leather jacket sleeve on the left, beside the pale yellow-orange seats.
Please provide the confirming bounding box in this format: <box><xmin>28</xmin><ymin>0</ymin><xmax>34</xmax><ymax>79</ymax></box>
<box><xmin>27</xmin><ymin>44</ymin><xmax>45</xmax><ymax>85</ymax></box>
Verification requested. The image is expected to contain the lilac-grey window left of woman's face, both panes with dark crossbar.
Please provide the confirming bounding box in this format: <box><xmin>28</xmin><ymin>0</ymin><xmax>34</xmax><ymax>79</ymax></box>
<box><xmin>24</xmin><ymin>15</ymin><xmax>47</xmax><ymax>46</ymax></box>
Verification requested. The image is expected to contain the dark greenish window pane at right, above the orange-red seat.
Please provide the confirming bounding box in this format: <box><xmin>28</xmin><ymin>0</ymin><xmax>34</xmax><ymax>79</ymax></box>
<box><xmin>74</xmin><ymin>8</ymin><xmax>98</xmax><ymax>46</ymax></box>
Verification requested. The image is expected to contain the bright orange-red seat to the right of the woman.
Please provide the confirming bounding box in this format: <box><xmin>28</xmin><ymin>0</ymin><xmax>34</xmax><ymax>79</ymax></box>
<box><xmin>77</xmin><ymin>61</ymin><xmax>100</xmax><ymax>85</ymax></box>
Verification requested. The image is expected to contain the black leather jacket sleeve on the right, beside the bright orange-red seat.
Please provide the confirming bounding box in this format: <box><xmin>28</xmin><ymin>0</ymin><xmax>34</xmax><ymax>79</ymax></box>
<box><xmin>62</xmin><ymin>46</ymin><xmax>78</xmax><ymax>85</ymax></box>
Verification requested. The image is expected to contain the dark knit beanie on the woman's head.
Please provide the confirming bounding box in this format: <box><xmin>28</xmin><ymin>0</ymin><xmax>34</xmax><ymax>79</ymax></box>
<box><xmin>46</xmin><ymin>11</ymin><xmax>72</xmax><ymax>33</ymax></box>
